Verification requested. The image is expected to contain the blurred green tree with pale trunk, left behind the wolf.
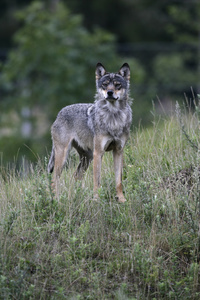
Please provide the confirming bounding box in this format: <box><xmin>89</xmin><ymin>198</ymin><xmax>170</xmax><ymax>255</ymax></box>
<box><xmin>0</xmin><ymin>2</ymin><xmax>144</xmax><ymax>164</ymax></box>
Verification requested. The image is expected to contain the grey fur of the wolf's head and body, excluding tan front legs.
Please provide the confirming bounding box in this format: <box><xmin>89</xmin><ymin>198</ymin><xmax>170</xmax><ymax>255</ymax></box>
<box><xmin>48</xmin><ymin>64</ymin><xmax>132</xmax><ymax>200</ymax></box>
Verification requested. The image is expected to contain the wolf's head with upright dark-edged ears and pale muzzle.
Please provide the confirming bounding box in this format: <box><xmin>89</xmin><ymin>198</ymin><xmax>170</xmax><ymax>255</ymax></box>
<box><xmin>96</xmin><ymin>63</ymin><xmax>130</xmax><ymax>102</ymax></box>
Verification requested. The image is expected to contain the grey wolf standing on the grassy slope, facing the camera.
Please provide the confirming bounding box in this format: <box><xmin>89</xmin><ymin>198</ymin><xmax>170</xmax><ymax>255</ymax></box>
<box><xmin>48</xmin><ymin>63</ymin><xmax>132</xmax><ymax>202</ymax></box>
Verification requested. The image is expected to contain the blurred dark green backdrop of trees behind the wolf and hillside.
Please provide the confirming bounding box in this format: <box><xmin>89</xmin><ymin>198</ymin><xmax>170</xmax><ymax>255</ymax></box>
<box><xmin>0</xmin><ymin>0</ymin><xmax>200</xmax><ymax>165</ymax></box>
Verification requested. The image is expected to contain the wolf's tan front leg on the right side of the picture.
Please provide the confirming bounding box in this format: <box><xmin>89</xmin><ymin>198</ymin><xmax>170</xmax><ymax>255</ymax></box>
<box><xmin>113</xmin><ymin>149</ymin><xmax>126</xmax><ymax>203</ymax></box>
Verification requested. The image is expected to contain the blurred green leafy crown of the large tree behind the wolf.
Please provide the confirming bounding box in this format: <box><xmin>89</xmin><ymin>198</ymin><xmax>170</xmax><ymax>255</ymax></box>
<box><xmin>1</xmin><ymin>2</ymin><xmax>116</xmax><ymax>117</ymax></box>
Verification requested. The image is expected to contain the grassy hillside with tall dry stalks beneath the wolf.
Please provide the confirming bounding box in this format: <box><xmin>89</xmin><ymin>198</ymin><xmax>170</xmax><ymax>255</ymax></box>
<box><xmin>0</xmin><ymin>107</ymin><xmax>200</xmax><ymax>300</ymax></box>
